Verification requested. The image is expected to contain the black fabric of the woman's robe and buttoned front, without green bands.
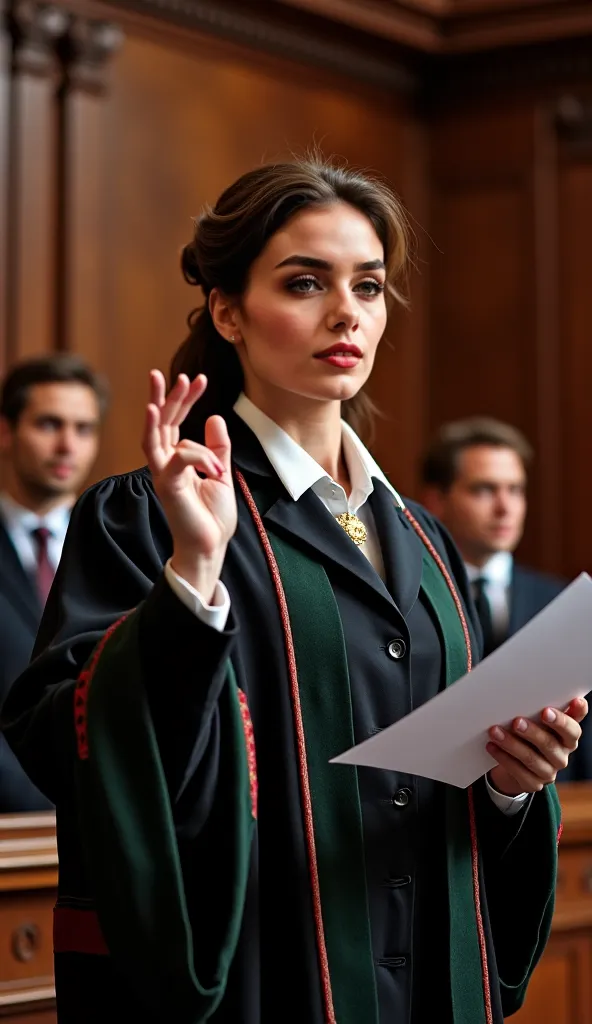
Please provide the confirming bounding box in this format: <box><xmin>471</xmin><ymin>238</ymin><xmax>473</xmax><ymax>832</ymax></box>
<box><xmin>4</xmin><ymin>417</ymin><xmax>554</xmax><ymax>1024</ymax></box>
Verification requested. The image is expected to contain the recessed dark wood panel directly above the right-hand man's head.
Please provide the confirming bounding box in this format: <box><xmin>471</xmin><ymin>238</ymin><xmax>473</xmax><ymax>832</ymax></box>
<box><xmin>430</xmin><ymin>182</ymin><xmax>528</xmax><ymax>427</ymax></box>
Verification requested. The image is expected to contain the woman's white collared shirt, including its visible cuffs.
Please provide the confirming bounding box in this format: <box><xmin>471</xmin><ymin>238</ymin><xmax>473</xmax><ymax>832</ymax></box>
<box><xmin>165</xmin><ymin>394</ymin><xmax>527</xmax><ymax>814</ymax></box>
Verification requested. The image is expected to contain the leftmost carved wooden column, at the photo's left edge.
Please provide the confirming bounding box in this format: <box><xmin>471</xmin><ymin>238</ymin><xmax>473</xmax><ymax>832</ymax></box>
<box><xmin>2</xmin><ymin>0</ymin><xmax>67</xmax><ymax>361</ymax></box>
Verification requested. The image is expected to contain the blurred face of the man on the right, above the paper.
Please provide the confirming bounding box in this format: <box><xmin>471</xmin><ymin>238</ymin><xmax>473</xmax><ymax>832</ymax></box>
<box><xmin>429</xmin><ymin>444</ymin><xmax>526</xmax><ymax>565</ymax></box>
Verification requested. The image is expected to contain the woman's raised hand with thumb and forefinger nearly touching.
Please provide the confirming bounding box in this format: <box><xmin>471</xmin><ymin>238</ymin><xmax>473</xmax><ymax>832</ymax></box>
<box><xmin>142</xmin><ymin>370</ymin><xmax>237</xmax><ymax>602</ymax></box>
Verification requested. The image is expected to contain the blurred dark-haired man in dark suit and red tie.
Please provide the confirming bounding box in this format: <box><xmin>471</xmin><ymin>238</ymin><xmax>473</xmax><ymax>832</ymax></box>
<box><xmin>0</xmin><ymin>354</ymin><xmax>108</xmax><ymax>813</ymax></box>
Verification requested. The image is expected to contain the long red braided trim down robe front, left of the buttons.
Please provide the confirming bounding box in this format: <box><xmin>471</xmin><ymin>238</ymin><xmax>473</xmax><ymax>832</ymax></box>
<box><xmin>236</xmin><ymin>470</ymin><xmax>336</xmax><ymax>1024</ymax></box>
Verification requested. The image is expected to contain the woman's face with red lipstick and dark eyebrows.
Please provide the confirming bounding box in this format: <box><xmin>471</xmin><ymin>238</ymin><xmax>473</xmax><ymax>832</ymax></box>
<box><xmin>214</xmin><ymin>203</ymin><xmax>386</xmax><ymax>409</ymax></box>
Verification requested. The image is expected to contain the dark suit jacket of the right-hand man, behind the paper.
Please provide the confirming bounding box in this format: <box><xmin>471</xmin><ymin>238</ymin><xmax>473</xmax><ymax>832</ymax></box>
<box><xmin>508</xmin><ymin>563</ymin><xmax>592</xmax><ymax>782</ymax></box>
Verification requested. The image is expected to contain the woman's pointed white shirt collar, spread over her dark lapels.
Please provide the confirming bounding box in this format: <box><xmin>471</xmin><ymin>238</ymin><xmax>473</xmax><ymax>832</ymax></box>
<box><xmin>235</xmin><ymin>393</ymin><xmax>405</xmax><ymax>508</ymax></box>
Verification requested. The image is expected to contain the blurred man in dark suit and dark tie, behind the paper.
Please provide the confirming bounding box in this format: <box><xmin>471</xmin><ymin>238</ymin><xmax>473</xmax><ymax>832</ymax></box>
<box><xmin>422</xmin><ymin>417</ymin><xmax>592</xmax><ymax>781</ymax></box>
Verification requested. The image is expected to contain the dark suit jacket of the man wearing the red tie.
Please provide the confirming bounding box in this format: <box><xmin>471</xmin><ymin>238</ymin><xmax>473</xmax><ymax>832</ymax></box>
<box><xmin>0</xmin><ymin>520</ymin><xmax>52</xmax><ymax>814</ymax></box>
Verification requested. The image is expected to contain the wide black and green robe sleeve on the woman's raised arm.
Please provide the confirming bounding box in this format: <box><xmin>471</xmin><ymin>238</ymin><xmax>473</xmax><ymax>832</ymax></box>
<box><xmin>3</xmin><ymin>471</ymin><xmax>254</xmax><ymax>1024</ymax></box>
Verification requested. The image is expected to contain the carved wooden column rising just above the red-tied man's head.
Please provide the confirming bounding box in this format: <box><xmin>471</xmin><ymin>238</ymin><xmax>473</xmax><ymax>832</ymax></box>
<box><xmin>55</xmin><ymin>17</ymin><xmax>123</xmax><ymax>366</ymax></box>
